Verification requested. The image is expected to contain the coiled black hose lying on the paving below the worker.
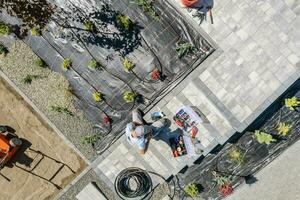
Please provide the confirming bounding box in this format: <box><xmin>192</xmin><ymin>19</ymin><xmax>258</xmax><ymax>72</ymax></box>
<box><xmin>115</xmin><ymin>167</ymin><xmax>153</xmax><ymax>199</ymax></box>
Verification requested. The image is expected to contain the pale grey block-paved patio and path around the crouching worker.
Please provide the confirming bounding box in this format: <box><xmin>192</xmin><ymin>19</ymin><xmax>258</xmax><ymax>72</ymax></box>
<box><xmin>94</xmin><ymin>0</ymin><xmax>300</xmax><ymax>192</ymax></box>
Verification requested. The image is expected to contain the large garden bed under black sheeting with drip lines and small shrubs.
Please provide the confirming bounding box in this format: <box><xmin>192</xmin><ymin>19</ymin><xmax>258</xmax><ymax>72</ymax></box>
<box><xmin>2</xmin><ymin>0</ymin><xmax>213</xmax><ymax>155</ymax></box>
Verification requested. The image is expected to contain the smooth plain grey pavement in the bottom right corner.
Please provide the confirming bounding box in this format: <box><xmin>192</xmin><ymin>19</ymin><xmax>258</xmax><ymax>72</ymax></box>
<box><xmin>226</xmin><ymin>142</ymin><xmax>300</xmax><ymax>200</ymax></box>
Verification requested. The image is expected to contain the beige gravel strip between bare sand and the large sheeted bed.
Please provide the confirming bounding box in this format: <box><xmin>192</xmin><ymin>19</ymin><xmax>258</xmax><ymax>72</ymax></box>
<box><xmin>0</xmin><ymin>42</ymin><xmax>96</xmax><ymax>160</ymax></box>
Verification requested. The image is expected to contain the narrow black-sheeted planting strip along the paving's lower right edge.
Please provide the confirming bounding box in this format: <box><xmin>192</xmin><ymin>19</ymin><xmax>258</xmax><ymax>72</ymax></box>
<box><xmin>178</xmin><ymin>81</ymin><xmax>300</xmax><ymax>199</ymax></box>
